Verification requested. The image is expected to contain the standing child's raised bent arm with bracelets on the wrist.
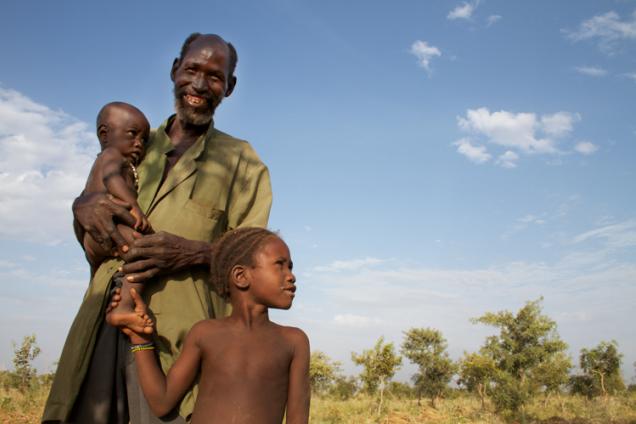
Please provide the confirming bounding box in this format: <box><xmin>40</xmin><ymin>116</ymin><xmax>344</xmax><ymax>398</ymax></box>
<box><xmin>122</xmin><ymin>289</ymin><xmax>201</xmax><ymax>417</ymax></box>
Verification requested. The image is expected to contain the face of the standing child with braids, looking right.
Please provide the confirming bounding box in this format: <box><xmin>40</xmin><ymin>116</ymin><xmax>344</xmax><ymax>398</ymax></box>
<box><xmin>250</xmin><ymin>237</ymin><xmax>296</xmax><ymax>309</ymax></box>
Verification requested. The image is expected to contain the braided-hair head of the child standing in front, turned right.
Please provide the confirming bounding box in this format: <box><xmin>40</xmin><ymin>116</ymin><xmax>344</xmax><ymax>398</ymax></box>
<box><xmin>210</xmin><ymin>227</ymin><xmax>296</xmax><ymax>309</ymax></box>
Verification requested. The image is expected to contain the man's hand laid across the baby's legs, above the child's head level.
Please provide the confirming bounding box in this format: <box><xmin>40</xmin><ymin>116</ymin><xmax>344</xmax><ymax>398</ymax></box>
<box><xmin>121</xmin><ymin>231</ymin><xmax>210</xmax><ymax>283</ymax></box>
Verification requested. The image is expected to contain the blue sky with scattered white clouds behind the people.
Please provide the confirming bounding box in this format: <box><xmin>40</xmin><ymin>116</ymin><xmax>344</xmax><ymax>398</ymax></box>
<box><xmin>0</xmin><ymin>0</ymin><xmax>636</xmax><ymax>379</ymax></box>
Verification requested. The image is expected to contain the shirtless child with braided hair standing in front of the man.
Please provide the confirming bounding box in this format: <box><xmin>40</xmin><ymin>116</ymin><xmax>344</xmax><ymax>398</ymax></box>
<box><xmin>113</xmin><ymin>228</ymin><xmax>310</xmax><ymax>424</ymax></box>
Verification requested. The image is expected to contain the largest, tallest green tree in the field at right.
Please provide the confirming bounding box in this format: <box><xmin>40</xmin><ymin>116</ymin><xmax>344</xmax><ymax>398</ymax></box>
<box><xmin>473</xmin><ymin>298</ymin><xmax>567</xmax><ymax>419</ymax></box>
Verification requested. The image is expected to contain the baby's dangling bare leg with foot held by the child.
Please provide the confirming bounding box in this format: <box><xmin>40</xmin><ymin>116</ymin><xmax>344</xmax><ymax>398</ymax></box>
<box><xmin>106</xmin><ymin>225</ymin><xmax>153</xmax><ymax>334</ymax></box>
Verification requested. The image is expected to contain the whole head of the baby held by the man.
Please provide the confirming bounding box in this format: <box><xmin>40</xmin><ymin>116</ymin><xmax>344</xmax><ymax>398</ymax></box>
<box><xmin>97</xmin><ymin>102</ymin><xmax>150</xmax><ymax>164</ymax></box>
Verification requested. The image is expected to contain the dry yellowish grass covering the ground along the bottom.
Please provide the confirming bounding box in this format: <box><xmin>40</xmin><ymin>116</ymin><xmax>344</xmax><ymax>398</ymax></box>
<box><xmin>0</xmin><ymin>386</ymin><xmax>636</xmax><ymax>424</ymax></box>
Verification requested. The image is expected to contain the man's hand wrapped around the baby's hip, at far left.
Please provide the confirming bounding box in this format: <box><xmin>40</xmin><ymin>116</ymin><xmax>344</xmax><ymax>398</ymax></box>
<box><xmin>73</xmin><ymin>193</ymin><xmax>135</xmax><ymax>251</ymax></box>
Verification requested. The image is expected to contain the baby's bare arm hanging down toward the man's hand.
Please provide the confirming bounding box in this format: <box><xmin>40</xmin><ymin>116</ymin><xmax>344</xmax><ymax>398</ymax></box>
<box><xmin>101</xmin><ymin>147</ymin><xmax>148</xmax><ymax>231</ymax></box>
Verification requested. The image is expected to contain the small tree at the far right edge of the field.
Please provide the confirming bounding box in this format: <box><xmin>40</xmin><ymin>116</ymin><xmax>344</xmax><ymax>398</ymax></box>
<box><xmin>570</xmin><ymin>340</ymin><xmax>625</xmax><ymax>397</ymax></box>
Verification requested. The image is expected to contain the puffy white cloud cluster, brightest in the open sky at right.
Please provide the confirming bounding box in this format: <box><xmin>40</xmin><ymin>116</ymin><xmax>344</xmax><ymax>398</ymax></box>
<box><xmin>454</xmin><ymin>107</ymin><xmax>581</xmax><ymax>168</ymax></box>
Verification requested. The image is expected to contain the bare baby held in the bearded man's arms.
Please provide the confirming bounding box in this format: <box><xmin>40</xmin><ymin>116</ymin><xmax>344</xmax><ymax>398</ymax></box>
<box><xmin>83</xmin><ymin>102</ymin><xmax>152</xmax><ymax>331</ymax></box>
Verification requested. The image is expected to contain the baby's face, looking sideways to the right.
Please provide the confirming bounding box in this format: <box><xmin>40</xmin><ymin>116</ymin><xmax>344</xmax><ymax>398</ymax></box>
<box><xmin>107</xmin><ymin>109</ymin><xmax>150</xmax><ymax>165</ymax></box>
